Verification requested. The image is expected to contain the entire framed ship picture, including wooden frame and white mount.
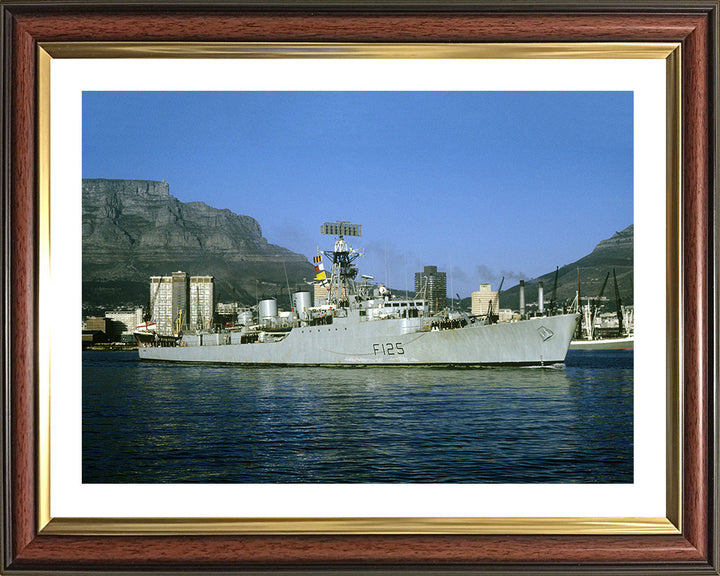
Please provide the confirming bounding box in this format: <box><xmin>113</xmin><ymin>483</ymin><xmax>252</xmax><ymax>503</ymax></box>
<box><xmin>1</xmin><ymin>0</ymin><xmax>720</xmax><ymax>574</ymax></box>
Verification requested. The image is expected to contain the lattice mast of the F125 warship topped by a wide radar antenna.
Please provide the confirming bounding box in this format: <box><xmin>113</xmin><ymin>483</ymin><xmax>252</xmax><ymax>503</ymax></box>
<box><xmin>320</xmin><ymin>220</ymin><xmax>362</xmax><ymax>308</ymax></box>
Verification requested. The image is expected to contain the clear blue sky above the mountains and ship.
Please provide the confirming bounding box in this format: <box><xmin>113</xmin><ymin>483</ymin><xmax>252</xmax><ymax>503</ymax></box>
<box><xmin>83</xmin><ymin>92</ymin><xmax>633</xmax><ymax>297</ymax></box>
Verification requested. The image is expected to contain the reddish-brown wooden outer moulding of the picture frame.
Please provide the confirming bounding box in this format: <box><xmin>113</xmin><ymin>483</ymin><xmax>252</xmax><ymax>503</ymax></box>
<box><xmin>0</xmin><ymin>0</ymin><xmax>720</xmax><ymax>574</ymax></box>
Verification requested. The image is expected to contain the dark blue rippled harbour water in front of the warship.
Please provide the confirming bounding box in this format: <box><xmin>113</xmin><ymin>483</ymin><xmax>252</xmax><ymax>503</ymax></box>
<box><xmin>82</xmin><ymin>350</ymin><xmax>633</xmax><ymax>483</ymax></box>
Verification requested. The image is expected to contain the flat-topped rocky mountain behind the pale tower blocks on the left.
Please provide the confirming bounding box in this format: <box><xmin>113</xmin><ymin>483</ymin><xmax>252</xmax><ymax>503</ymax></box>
<box><xmin>82</xmin><ymin>179</ymin><xmax>314</xmax><ymax>307</ymax></box>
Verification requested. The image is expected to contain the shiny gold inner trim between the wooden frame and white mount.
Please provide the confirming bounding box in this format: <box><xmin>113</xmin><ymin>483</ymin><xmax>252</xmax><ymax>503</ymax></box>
<box><xmin>37</xmin><ymin>42</ymin><xmax>682</xmax><ymax>535</ymax></box>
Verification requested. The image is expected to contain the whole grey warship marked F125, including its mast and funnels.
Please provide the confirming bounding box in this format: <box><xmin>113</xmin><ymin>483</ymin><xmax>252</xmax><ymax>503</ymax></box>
<box><xmin>138</xmin><ymin>222</ymin><xmax>578</xmax><ymax>366</ymax></box>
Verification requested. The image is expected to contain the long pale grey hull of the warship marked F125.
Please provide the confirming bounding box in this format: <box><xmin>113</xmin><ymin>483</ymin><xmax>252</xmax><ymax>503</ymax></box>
<box><xmin>138</xmin><ymin>313</ymin><xmax>578</xmax><ymax>366</ymax></box>
